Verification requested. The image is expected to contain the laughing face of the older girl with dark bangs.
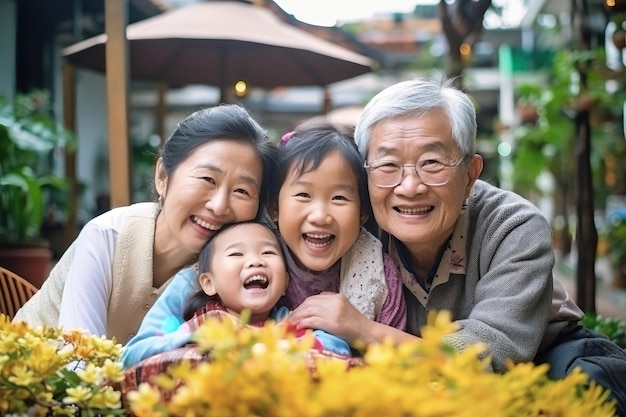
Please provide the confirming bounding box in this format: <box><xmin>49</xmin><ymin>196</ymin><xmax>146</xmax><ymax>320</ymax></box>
<box><xmin>277</xmin><ymin>151</ymin><xmax>362</xmax><ymax>272</ymax></box>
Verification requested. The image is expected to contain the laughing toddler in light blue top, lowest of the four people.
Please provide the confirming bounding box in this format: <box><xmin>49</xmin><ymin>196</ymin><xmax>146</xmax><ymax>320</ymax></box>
<box><xmin>122</xmin><ymin>222</ymin><xmax>350</xmax><ymax>367</ymax></box>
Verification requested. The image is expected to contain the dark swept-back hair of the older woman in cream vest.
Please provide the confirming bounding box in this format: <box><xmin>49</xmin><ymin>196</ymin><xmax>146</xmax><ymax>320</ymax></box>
<box><xmin>159</xmin><ymin>104</ymin><xmax>277</xmax><ymax>213</ymax></box>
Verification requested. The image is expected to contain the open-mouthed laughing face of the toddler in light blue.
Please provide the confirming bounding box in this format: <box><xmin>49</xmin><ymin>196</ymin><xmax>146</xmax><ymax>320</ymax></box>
<box><xmin>200</xmin><ymin>223</ymin><xmax>288</xmax><ymax>322</ymax></box>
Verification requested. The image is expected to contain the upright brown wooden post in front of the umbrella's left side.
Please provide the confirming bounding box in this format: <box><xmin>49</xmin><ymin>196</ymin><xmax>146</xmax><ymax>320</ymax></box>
<box><xmin>105</xmin><ymin>0</ymin><xmax>131</xmax><ymax>207</ymax></box>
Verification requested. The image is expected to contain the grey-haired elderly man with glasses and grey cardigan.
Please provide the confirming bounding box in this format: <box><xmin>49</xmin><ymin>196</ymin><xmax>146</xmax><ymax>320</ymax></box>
<box><xmin>292</xmin><ymin>79</ymin><xmax>626</xmax><ymax>416</ymax></box>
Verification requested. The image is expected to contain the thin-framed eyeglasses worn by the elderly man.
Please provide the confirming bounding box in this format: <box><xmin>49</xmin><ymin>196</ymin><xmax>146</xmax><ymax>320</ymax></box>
<box><xmin>363</xmin><ymin>157</ymin><xmax>465</xmax><ymax>188</ymax></box>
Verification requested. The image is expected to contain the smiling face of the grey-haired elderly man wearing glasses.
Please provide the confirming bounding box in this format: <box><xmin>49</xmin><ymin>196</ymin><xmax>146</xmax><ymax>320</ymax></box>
<box><xmin>367</xmin><ymin>110</ymin><xmax>482</xmax><ymax>256</ymax></box>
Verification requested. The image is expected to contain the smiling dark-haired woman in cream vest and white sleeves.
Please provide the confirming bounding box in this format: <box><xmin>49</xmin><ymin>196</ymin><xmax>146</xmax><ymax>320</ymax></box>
<box><xmin>14</xmin><ymin>105</ymin><xmax>276</xmax><ymax>344</ymax></box>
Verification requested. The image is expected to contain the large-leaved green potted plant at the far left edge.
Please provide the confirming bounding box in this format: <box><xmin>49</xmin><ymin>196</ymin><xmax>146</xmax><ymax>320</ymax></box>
<box><xmin>0</xmin><ymin>90</ymin><xmax>76</xmax><ymax>241</ymax></box>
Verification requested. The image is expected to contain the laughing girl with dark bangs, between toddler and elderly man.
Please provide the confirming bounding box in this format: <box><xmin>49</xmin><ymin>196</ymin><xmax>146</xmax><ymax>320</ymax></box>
<box><xmin>269</xmin><ymin>124</ymin><xmax>406</xmax><ymax>343</ymax></box>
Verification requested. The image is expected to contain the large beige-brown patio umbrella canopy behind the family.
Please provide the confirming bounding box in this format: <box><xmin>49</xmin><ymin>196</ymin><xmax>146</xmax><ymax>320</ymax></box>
<box><xmin>63</xmin><ymin>1</ymin><xmax>374</xmax><ymax>89</ymax></box>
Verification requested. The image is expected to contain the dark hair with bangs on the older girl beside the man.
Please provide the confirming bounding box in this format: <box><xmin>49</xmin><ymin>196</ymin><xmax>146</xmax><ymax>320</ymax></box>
<box><xmin>271</xmin><ymin>122</ymin><xmax>371</xmax><ymax>217</ymax></box>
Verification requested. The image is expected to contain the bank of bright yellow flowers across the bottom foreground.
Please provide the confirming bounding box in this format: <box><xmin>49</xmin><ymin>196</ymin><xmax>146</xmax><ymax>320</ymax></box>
<box><xmin>0</xmin><ymin>312</ymin><xmax>615</xmax><ymax>417</ymax></box>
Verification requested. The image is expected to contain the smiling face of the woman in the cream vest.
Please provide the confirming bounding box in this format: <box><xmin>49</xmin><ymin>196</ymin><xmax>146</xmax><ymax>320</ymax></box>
<box><xmin>155</xmin><ymin>139</ymin><xmax>263</xmax><ymax>255</ymax></box>
